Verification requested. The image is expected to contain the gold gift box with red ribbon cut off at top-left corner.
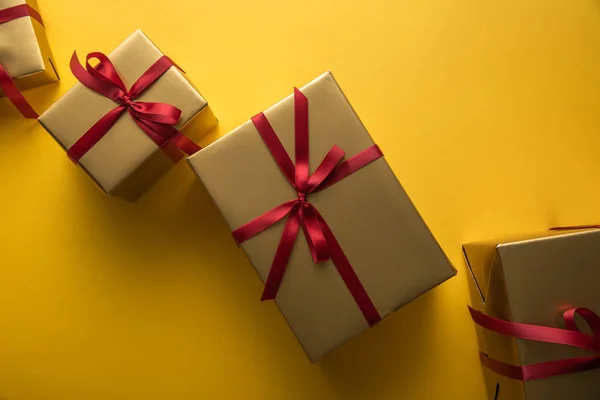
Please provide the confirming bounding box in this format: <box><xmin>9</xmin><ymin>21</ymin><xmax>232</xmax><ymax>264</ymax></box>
<box><xmin>0</xmin><ymin>0</ymin><xmax>58</xmax><ymax>118</ymax></box>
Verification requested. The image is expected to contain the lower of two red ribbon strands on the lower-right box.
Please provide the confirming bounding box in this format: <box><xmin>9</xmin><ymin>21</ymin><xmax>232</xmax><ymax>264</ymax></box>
<box><xmin>479</xmin><ymin>353</ymin><xmax>600</xmax><ymax>381</ymax></box>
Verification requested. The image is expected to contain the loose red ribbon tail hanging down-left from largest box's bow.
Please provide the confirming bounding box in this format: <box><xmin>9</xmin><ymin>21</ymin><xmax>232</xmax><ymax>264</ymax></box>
<box><xmin>261</xmin><ymin>206</ymin><xmax>300</xmax><ymax>301</ymax></box>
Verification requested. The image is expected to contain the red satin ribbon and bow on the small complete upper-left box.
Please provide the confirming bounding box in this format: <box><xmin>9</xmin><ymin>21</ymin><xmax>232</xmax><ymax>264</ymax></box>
<box><xmin>67</xmin><ymin>52</ymin><xmax>200</xmax><ymax>163</ymax></box>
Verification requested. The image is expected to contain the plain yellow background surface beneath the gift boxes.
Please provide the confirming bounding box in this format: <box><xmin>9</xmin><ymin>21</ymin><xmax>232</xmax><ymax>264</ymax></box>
<box><xmin>0</xmin><ymin>0</ymin><xmax>600</xmax><ymax>400</ymax></box>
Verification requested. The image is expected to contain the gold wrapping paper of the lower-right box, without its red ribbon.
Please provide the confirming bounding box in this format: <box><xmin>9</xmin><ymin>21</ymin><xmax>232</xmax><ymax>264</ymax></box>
<box><xmin>463</xmin><ymin>230</ymin><xmax>600</xmax><ymax>400</ymax></box>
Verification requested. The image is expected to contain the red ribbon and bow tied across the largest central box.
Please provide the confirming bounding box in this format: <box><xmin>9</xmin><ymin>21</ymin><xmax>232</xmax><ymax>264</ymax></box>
<box><xmin>233</xmin><ymin>88</ymin><xmax>383</xmax><ymax>326</ymax></box>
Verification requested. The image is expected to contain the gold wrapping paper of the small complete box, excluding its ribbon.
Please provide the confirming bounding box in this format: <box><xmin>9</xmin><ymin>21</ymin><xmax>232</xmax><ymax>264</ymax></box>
<box><xmin>39</xmin><ymin>30</ymin><xmax>217</xmax><ymax>199</ymax></box>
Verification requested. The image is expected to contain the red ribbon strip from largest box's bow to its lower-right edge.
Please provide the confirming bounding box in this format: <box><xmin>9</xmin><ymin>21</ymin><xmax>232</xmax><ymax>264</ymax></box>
<box><xmin>315</xmin><ymin>210</ymin><xmax>381</xmax><ymax>326</ymax></box>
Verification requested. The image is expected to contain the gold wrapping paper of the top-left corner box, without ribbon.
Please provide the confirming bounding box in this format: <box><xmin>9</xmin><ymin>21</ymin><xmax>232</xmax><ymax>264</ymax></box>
<box><xmin>0</xmin><ymin>0</ymin><xmax>58</xmax><ymax>95</ymax></box>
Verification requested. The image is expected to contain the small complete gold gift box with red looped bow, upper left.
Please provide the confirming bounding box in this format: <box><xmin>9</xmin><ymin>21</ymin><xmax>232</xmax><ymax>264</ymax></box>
<box><xmin>39</xmin><ymin>30</ymin><xmax>217</xmax><ymax>200</ymax></box>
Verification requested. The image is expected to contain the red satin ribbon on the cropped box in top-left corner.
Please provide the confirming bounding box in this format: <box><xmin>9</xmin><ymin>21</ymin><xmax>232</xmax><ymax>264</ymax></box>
<box><xmin>0</xmin><ymin>4</ymin><xmax>44</xmax><ymax>119</ymax></box>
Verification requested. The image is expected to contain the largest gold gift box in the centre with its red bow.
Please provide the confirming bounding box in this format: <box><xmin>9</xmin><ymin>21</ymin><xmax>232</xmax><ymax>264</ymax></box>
<box><xmin>188</xmin><ymin>73</ymin><xmax>456</xmax><ymax>361</ymax></box>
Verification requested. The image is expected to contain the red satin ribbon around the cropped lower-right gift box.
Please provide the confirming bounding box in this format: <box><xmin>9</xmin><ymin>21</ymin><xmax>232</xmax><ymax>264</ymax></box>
<box><xmin>469</xmin><ymin>307</ymin><xmax>600</xmax><ymax>381</ymax></box>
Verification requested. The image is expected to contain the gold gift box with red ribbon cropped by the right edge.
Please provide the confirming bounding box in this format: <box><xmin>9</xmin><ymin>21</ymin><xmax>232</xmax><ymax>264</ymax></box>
<box><xmin>463</xmin><ymin>229</ymin><xmax>600</xmax><ymax>400</ymax></box>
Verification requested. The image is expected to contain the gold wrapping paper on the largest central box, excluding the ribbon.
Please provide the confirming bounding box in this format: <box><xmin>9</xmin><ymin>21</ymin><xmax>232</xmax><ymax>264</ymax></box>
<box><xmin>188</xmin><ymin>73</ymin><xmax>455</xmax><ymax>361</ymax></box>
